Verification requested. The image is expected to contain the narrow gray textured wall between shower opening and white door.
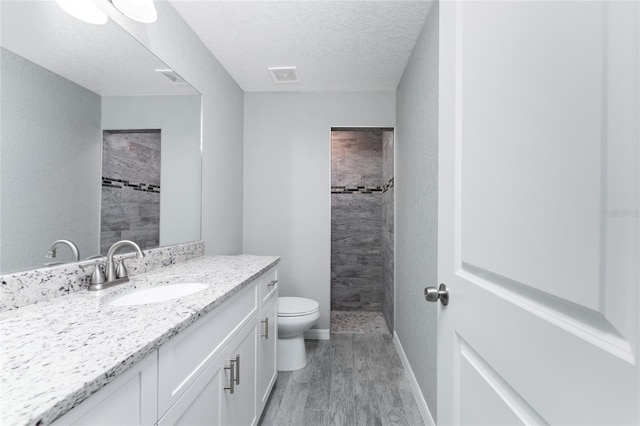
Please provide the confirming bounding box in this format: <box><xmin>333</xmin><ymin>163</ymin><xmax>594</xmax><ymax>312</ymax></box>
<box><xmin>395</xmin><ymin>2</ymin><xmax>438</xmax><ymax>419</ymax></box>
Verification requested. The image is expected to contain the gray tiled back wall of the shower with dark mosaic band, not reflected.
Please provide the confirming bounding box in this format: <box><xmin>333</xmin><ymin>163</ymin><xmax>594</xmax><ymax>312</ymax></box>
<box><xmin>331</xmin><ymin>129</ymin><xmax>384</xmax><ymax>311</ymax></box>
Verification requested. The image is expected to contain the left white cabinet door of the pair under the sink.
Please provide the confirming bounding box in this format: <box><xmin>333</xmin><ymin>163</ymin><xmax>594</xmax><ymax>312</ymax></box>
<box><xmin>158</xmin><ymin>353</ymin><xmax>229</xmax><ymax>426</ymax></box>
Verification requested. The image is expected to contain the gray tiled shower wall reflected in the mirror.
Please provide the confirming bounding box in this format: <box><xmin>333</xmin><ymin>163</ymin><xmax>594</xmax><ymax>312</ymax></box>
<box><xmin>100</xmin><ymin>130</ymin><xmax>160</xmax><ymax>255</ymax></box>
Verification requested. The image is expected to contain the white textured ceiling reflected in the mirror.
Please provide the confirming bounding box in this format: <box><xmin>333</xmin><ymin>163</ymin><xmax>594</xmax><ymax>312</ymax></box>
<box><xmin>0</xmin><ymin>0</ymin><xmax>197</xmax><ymax>96</ymax></box>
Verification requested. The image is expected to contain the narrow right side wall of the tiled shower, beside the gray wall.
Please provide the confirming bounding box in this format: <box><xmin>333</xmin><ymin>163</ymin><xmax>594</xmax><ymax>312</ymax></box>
<box><xmin>382</xmin><ymin>130</ymin><xmax>394</xmax><ymax>330</ymax></box>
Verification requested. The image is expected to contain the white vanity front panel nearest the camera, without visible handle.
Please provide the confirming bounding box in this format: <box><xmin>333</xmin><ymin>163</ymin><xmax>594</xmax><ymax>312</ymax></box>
<box><xmin>54</xmin><ymin>351</ymin><xmax>158</xmax><ymax>426</ymax></box>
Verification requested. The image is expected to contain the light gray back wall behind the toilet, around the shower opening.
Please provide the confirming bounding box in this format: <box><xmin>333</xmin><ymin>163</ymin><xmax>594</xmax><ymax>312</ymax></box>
<box><xmin>244</xmin><ymin>92</ymin><xmax>395</xmax><ymax>330</ymax></box>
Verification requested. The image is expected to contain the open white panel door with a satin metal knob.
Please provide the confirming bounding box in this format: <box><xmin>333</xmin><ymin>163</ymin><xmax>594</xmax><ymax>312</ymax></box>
<box><xmin>437</xmin><ymin>1</ymin><xmax>640</xmax><ymax>425</ymax></box>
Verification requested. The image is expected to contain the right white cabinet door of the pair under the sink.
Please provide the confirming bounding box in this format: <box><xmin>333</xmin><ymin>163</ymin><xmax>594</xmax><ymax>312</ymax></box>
<box><xmin>223</xmin><ymin>316</ymin><xmax>258</xmax><ymax>426</ymax></box>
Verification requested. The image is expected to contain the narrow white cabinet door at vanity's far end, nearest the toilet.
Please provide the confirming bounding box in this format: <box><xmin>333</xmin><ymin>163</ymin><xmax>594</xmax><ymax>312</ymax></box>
<box><xmin>257</xmin><ymin>292</ymin><xmax>278</xmax><ymax>413</ymax></box>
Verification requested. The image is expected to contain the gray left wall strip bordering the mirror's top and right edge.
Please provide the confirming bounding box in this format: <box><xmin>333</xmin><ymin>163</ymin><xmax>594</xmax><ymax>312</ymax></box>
<box><xmin>108</xmin><ymin>1</ymin><xmax>244</xmax><ymax>254</ymax></box>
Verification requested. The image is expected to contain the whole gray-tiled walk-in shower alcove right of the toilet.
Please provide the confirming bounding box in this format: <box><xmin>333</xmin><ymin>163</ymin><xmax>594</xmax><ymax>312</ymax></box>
<box><xmin>331</xmin><ymin>128</ymin><xmax>394</xmax><ymax>331</ymax></box>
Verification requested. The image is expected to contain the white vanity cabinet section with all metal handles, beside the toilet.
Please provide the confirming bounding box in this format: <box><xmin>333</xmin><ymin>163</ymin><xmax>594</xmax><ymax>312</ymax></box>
<box><xmin>158</xmin><ymin>268</ymin><xmax>278</xmax><ymax>426</ymax></box>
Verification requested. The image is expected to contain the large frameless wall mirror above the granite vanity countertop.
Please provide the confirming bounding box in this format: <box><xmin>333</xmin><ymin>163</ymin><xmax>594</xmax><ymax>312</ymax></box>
<box><xmin>0</xmin><ymin>0</ymin><xmax>202</xmax><ymax>274</ymax></box>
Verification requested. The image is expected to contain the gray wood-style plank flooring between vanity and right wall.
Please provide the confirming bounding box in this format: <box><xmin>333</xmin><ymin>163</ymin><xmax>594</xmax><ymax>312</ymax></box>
<box><xmin>260</xmin><ymin>333</ymin><xmax>424</xmax><ymax>426</ymax></box>
